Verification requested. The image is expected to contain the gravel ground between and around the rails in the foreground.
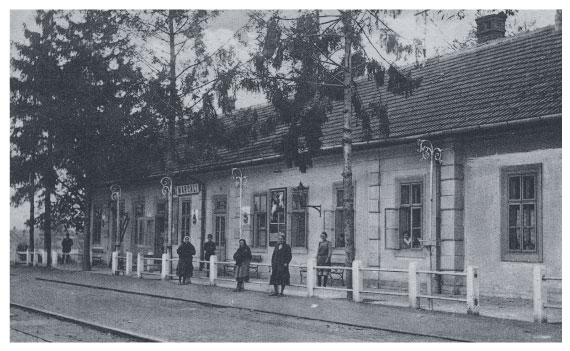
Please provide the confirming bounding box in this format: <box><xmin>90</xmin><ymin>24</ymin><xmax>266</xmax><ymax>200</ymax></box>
<box><xmin>11</xmin><ymin>275</ymin><xmax>442</xmax><ymax>342</ymax></box>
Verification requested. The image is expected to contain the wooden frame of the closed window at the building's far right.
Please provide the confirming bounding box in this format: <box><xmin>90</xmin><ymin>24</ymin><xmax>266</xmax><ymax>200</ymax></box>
<box><xmin>500</xmin><ymin>163</ymin><xmax>543</xmax><ymax>262</ymax></box>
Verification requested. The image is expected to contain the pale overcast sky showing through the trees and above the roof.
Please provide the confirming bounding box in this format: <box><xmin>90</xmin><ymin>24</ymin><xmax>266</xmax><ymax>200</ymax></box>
<box><xmin>10</xmin><ymin>10</ymin><xmax>555</xmax><ymax>229</ymax></box>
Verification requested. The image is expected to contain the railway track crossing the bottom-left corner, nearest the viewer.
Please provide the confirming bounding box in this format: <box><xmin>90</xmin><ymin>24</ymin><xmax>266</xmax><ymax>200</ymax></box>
<box><xmin>10</xmin><ymin>302</ymin><xmax>165</xmax><ymax>342</ymax></box>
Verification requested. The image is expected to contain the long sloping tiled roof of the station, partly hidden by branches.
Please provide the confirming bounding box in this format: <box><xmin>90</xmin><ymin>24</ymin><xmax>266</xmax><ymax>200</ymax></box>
<box><xmin>155</xmin><ymin>27</ymin><xmax>562</xmax><ymax>176</ymax></box>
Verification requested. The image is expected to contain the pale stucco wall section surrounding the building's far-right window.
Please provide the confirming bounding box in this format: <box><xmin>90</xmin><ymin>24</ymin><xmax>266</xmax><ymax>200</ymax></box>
<box><xmin>465</xmin><ymin>149</ymin><xmax>562</xmax><ymax>297</ymax></box>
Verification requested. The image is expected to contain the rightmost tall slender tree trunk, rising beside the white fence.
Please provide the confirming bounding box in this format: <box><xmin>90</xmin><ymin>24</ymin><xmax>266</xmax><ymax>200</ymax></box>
<box><xmin>342</xmin><ymin>11</ymin><xmax>354</xmax><ymax>299</ymax></box>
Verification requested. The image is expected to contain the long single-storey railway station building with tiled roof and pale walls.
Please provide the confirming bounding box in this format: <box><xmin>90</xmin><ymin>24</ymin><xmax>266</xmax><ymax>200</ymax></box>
<box><xmin>87</xmin><ymin>14</ymin><xmax>562</xmax><ymax>297</ymax></box>
